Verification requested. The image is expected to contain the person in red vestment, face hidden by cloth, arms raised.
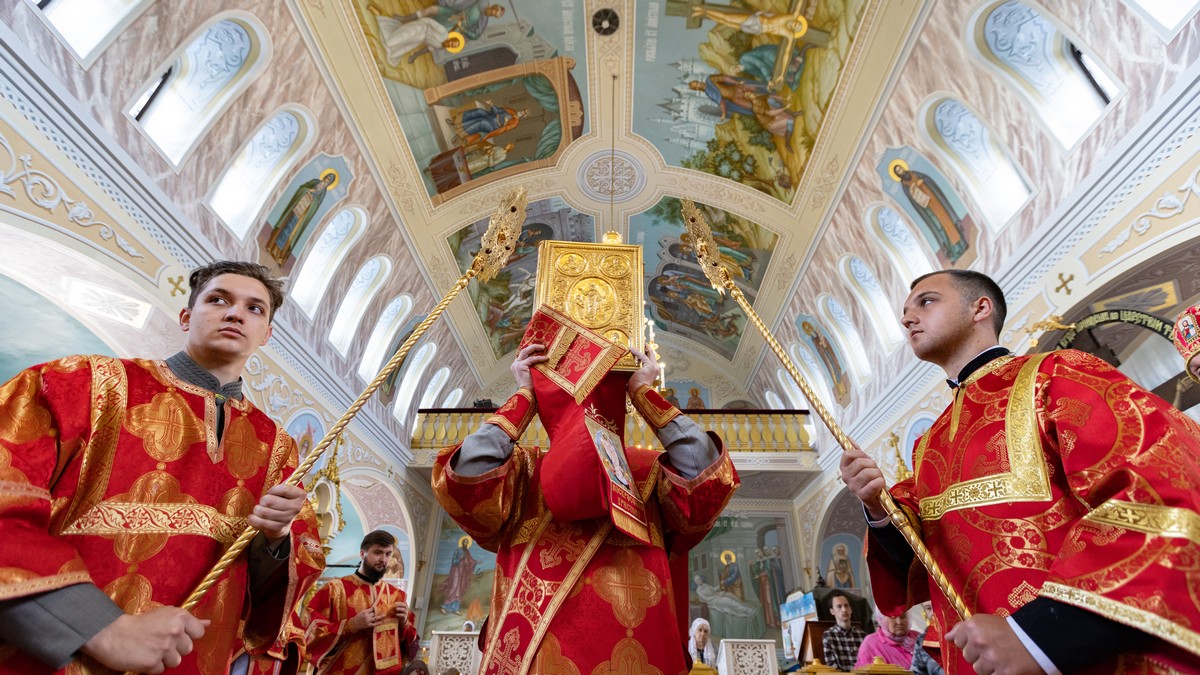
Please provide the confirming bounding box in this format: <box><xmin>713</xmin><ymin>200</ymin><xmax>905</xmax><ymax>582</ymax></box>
<box><xmin>433</xmin><ymin>306</ymin><xmax>738</xmax><ymax>675</ymax></box>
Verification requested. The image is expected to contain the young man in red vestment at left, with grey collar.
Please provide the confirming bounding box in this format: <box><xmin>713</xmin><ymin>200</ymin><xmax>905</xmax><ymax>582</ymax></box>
<box><xmin>0</xmin><ymin>261</ymin><xmax>324</xmax><ymax>675</ymax></box>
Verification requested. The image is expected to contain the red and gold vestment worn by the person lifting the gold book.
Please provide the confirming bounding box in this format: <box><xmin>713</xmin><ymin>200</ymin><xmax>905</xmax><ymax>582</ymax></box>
<box><xmin>433</xmin><ymin>390</ymin><xmax>738</xmax><ymax>675</ymax></box>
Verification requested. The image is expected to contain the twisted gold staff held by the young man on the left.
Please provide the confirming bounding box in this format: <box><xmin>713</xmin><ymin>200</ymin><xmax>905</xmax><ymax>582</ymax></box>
<box><xmin>181</xmin><ymin>187</ymin><xmax>530</xmax><ymax>611</ymax></box>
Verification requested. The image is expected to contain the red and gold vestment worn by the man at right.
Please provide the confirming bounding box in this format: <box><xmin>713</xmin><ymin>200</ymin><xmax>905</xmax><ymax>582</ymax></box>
<box><xmin>868</xmin><ymin>351</ymin><xmax>1200</xmax><ymax>675</ymax></box>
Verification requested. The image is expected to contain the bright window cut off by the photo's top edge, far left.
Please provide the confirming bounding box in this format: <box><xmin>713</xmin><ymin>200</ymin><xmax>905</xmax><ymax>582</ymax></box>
<box><xmin>37</xmin><ymin>0</ymin><xmax>152</xmax><ymax>70</ymax></box>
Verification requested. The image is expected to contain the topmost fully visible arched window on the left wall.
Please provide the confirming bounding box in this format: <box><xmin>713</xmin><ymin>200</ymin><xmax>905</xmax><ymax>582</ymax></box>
<box><xmin>128</xmin><ymin>12</ymin><xmax>270</xmax><ymax>169</ymax></box>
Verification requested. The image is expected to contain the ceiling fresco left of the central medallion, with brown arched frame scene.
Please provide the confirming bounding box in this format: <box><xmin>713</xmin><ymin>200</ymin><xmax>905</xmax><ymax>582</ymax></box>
<box><xmin>354</xmin><ymin>0</ymin><xmax>586</xmax><ymax>203</ymax></box>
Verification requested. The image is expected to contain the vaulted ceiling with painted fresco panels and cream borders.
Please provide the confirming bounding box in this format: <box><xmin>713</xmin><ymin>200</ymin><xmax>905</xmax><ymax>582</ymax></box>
<box><xmin>300</xmin><ymin>0</ymin><xmax>916</xmax><ymax>389</ymax></box>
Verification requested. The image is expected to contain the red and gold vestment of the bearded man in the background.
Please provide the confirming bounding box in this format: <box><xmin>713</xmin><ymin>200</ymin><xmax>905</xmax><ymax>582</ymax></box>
<box><xmin>305</xmin><ymin>574</ymin><xmax>420</xmax><ymax>675</ymax></box>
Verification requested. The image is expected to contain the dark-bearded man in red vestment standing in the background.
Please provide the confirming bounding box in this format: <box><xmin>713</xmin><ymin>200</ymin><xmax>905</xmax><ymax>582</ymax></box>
<box><xmin>305</xmin><ymin>530</ymin><xmax>420</xmax><ymax>675</ymax></box>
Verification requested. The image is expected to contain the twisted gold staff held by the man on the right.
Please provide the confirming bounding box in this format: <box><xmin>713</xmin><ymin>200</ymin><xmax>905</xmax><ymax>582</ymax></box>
<box><xmin>682</xmin><ymin>199</ymin><xmax>971</xmax><ymax>620</ymax></box>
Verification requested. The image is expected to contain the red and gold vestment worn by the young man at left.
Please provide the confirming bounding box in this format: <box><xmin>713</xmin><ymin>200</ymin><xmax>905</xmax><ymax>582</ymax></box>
<box><xmin>0</xmin><ymin>357</ymin><xmax>324</xmax><ymax>675</ymax></box>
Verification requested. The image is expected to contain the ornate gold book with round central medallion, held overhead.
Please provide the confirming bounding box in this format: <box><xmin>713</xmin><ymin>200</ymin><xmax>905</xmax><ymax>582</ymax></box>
<box><xmin>534</xmin><ymin>240</ymin><xmax>644</xmax><ymax>371</ymax></box>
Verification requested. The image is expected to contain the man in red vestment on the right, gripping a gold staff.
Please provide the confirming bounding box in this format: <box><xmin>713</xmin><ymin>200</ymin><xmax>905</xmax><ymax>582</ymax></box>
<box><xmin>841</xmin><ymin>270</ymin><xmax>1200</xmax><ymax>675</ymax></box>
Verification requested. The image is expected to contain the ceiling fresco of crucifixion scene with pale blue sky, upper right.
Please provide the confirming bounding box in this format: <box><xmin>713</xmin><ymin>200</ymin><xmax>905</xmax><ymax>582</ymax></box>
<box><xmin>634</xmin><ymin>0</ymin><xmax>866</xmax><ymax>203</ymax></box>
